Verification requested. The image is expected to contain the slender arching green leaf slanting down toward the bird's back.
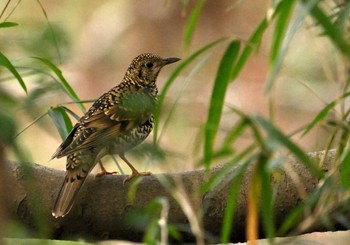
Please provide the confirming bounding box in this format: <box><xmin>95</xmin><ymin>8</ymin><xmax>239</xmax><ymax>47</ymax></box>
<box><xmin>33</xmin><ymin>57</ymin><xmax>86</xmax><ymax>112</ymax></box>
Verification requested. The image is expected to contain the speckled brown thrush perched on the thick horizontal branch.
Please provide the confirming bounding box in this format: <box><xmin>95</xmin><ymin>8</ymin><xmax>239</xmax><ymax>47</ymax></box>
<box><xmin>51</xmin><ymin>53</ymin><xmax>180</xmax><ymax>218</ymax></box>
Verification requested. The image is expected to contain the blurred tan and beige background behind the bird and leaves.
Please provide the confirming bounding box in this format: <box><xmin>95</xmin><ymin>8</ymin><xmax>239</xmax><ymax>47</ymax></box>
<box><xmin>0</xmin><ymin>0</ymin><xmax>345</xmax><ymax>172</ymax></box>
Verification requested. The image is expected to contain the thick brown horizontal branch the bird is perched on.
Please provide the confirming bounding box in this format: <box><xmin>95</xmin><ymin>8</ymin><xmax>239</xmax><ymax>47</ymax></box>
<box><xmin>7</xmin><ymin>151</ymin><xmax>335</xmax><ymax>241</ymax></box>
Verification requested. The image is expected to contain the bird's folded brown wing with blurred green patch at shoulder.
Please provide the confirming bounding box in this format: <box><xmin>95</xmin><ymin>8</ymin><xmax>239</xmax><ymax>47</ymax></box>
<box><xmin>52</xmin><ymin>89</ymin><xmax>154</xmax><ymax>158</ymax></box>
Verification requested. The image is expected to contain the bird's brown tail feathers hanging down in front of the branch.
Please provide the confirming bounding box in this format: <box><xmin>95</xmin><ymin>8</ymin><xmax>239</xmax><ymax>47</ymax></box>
<box><xmin>52</xmin><ymin>173</ymin><xmax>86</xmax><ymax>218</ymax></box>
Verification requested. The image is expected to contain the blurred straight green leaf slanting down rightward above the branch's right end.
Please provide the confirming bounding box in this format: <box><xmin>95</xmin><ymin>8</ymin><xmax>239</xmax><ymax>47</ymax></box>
<box><xmin>253</xmin><ymin>116</ymin><xmax>324</xmax><ymax>178</ymax></box>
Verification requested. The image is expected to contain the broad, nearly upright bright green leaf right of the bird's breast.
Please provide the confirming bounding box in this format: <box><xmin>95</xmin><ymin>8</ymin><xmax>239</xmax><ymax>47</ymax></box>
<box><xmin>204</xmin><ymin>40</ymin><xmax>240</xmax><ymax>167</ymax></box>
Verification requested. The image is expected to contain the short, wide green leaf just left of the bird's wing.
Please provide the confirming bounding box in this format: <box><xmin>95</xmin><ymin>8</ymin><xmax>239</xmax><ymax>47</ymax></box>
<box><xmin>48</xmin><ymin>107</ymin><xmax>73</xmax><ymax>140</ymax></box>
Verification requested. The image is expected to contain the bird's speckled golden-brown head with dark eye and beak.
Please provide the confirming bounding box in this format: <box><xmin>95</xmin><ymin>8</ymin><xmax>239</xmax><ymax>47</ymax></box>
<box><xmin>127</xmin><ymin>53</ymin><xmax>180</xmax><ymax>84</ymax></box>
